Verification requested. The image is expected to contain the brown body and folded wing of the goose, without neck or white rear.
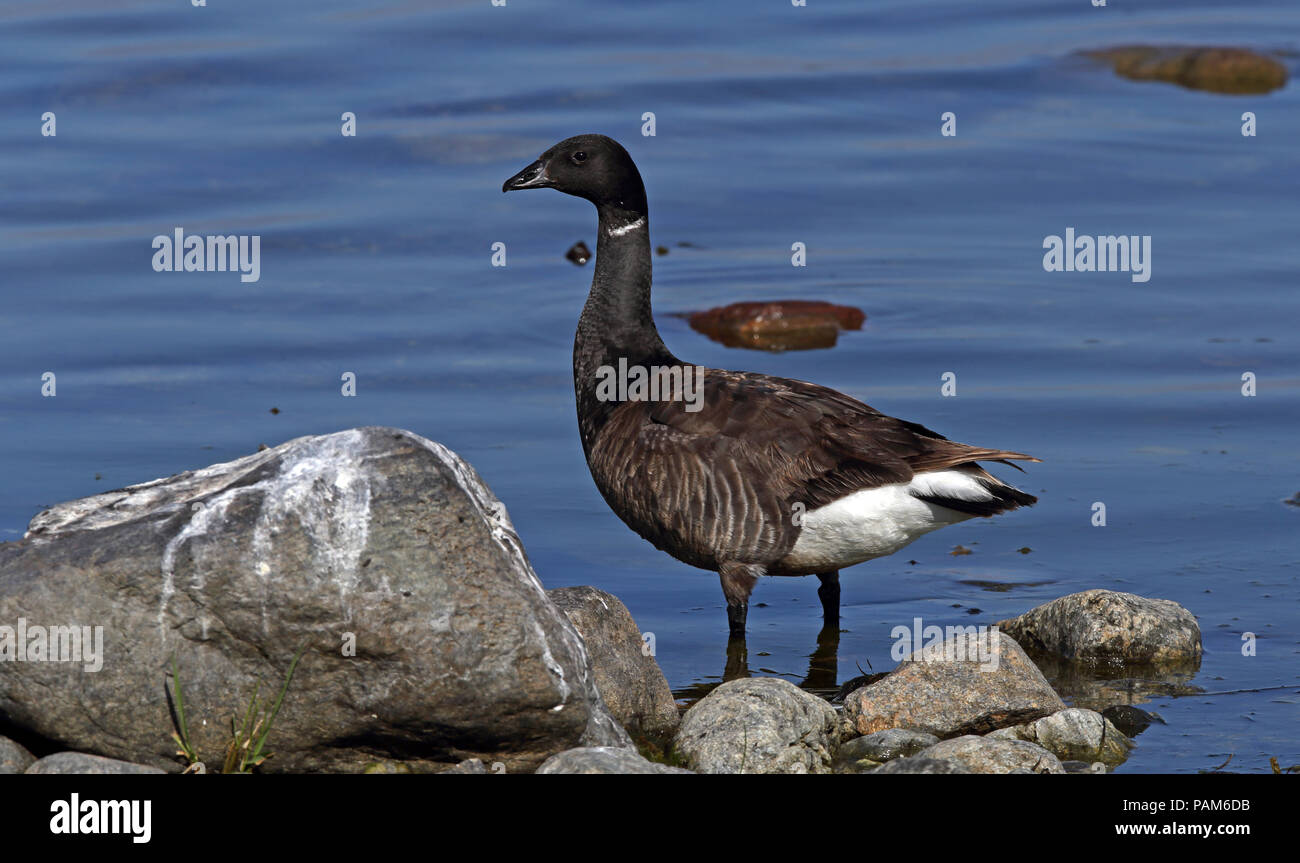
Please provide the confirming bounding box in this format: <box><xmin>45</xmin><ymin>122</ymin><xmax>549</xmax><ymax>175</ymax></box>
<box><xmin>589</xmin><ymin>367</ymin><xmax>1030</xmax><ymax>569</ymax></box>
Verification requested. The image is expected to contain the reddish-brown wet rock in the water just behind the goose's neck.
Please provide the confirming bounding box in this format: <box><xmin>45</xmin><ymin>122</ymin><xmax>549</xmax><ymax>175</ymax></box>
<box><xmin>686</xmin><ymin>300</ymin><xmax>867</xmax><ymax>351</ymax></box>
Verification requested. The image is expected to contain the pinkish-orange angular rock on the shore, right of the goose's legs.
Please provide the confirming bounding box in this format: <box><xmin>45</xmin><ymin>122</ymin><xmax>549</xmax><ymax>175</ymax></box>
<box><xmin>844</xmin><ymin>628</ymin><xmax>1065</xmax><ymax>738</ymax></box>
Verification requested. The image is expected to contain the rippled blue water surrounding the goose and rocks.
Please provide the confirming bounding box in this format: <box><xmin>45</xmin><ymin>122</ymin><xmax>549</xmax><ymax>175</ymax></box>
<box><xmin>0</xmin><ymin>0</ymin><xmax>1300</xmax><ymax>772</ymax></box>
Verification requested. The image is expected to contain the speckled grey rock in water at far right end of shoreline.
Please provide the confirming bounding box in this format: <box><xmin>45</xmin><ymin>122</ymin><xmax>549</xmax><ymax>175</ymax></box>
<box><xmin>997</xmin><ymin>590</ymin><xmax>1201</xmax><ymax>665</ymax></box>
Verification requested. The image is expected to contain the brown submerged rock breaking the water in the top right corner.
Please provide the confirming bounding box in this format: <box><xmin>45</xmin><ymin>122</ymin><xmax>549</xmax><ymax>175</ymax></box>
<box><xmin>1083</xmin><ymin>45</ymin><xmax>1287</xmax><ymax>94</ymax></box>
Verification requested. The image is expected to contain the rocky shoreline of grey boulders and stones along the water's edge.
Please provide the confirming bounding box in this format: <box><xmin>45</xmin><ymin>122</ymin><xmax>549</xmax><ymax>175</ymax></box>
<box><xmin>0</xmin><ymin>428</ymin><xmax>1201</xmax><ymax>773</ymax></box>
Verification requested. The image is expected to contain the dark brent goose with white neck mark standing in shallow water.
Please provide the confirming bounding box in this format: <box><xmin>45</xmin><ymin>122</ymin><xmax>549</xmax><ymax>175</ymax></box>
<box><xmin>502</xmin><ymin>135</ymin><xmax>1037</xmax><ymax>637</ymax></box>
